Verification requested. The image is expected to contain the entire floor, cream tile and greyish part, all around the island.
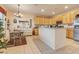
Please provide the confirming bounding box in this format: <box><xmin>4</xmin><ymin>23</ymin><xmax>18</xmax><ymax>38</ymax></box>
<box><xmin>0</xmin><ymin>36</ymin><xmax>79</xmax><ymax>54</ymax></box>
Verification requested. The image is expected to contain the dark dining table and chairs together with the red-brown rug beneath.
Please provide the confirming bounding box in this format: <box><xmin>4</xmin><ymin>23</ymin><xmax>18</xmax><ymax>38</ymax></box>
<box><xmin>7</xmin><ymin>31</ymin><xmax>27</xmax><ymax>47</ymax></box>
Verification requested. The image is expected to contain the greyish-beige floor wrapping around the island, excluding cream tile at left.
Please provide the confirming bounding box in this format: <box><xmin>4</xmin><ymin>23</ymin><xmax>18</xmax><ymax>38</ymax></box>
<box><xmin>33</xmin><ymin>35</ymin><xmax>79</xmax><ymax>54</ymax></box>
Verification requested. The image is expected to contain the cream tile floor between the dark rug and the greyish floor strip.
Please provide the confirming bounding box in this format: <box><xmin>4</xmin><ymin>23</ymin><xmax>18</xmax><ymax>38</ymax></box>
<box><xmin>2</xmin><ymin>36</ymin><xmax>40</xmax><ymax>54</ymax></box>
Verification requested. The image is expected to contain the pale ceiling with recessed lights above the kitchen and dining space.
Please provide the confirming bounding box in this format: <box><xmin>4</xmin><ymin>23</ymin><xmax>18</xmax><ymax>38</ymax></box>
<box><xmin>4</xmin><ymin>4</ymin><xmax>79</xmax><ymax>16</ymax></box>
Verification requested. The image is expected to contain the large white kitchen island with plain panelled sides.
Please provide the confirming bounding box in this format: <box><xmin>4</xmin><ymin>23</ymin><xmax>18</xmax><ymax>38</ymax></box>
<box><xmin>39</xmin><ymin>27</ymin><xmax>66</xmax><ymax>50</ymax></box>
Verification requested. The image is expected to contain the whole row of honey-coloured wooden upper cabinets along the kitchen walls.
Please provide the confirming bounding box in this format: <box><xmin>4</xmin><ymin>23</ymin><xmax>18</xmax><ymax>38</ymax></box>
<box><xmin>35</xmin><ymin>10</ymin><xmax>79</xmax><ymax>25</ymax></box>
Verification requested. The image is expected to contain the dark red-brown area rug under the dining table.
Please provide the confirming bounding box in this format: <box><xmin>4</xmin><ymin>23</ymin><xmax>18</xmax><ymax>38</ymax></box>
<box><xmin>7</xmin><ymin>37</ymin><xmax>27</xmax><ymax>48</ymax></box>
